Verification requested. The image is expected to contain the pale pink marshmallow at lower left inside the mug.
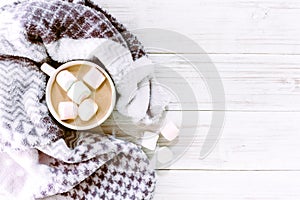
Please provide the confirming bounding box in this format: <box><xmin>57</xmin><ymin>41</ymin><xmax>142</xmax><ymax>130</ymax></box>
<box><xmin>58</xmin><ymin>101</ymin><xmax>78</xmax><ymax>120</ymax></box>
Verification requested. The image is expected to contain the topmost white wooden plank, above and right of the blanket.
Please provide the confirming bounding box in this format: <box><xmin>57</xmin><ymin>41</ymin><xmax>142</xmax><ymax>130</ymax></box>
<box><xmin>99</xmin><ymin>0</ymin><xmax>300</xmax><ymax>54</ymax></box>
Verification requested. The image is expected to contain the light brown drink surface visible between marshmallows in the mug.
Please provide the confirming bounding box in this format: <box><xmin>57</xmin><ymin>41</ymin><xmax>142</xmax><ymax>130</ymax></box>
<box><xmin>50</xmin><ymin>64</ymin><xmax>112</xmax><ymax>126</ymax></box>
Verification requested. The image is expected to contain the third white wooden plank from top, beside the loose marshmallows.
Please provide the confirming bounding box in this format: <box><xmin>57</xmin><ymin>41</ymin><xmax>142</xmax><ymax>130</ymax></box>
<box><xmin>102</xmin><ymin>111</ymin><xmax>300</xmax><ymax>170</ymax></box>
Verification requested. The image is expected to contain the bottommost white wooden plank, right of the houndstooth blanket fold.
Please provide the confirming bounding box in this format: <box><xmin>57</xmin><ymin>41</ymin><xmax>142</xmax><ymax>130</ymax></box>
<box><xmin>154</xmin><ymin>170</ymin><xmax>300</xmax><ymax>200</ymax></box>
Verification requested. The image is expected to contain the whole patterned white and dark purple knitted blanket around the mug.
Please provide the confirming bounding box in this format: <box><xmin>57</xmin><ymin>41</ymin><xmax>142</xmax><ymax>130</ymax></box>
<box><xmin>0</xmin><ymin>0</ymin><xmax>167</xmax><ymax>199</ymax></box>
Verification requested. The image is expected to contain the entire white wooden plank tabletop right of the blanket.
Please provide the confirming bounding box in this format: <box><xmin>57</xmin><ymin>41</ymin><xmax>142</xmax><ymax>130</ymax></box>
<box><xmin>101</xmin><ymin>0</ymin><xmax>300</xmax><ymax>200</ymax></box>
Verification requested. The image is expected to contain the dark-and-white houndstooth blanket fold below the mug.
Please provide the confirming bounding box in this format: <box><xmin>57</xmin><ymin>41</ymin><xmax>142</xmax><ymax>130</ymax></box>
<box><xmin>36</xmin><ymin>132</ymin><xmax>155</xmax><ymax>199</ymax></box>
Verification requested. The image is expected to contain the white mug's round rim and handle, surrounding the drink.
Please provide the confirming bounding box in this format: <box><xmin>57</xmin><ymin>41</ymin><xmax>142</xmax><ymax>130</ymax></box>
<box><xmin>41</xmin><ymin>60</ymin><xmax>116</xmax><ymax>130</ymax></box>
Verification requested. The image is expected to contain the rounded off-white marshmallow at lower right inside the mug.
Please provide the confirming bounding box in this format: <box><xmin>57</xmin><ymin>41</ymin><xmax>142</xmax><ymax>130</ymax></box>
<box><xmin>78</xmin><ymin>99</ymin><xmax>98</xmax><ymax>121</ymax></box>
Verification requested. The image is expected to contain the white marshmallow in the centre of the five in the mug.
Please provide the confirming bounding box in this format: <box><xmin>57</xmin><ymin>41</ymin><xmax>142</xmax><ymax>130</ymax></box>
<box><xmin>67</xmin><ymin>81</ymin><xmax>91</xmax><ymax>104</ymax></box>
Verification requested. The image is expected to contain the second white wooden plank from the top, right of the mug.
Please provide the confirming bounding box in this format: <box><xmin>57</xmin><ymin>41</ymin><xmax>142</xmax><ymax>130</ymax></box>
<box><xmin>150</xmin><ymin>54</ymin><xmax>300</xmax><ymax>111</ymax></box>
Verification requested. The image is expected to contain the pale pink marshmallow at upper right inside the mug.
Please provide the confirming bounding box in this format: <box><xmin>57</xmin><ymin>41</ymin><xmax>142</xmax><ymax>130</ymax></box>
<box><xmin>82</xmin><ymin>67</ymin><xmax>105</xmax><ymax>90</ymax></box>
